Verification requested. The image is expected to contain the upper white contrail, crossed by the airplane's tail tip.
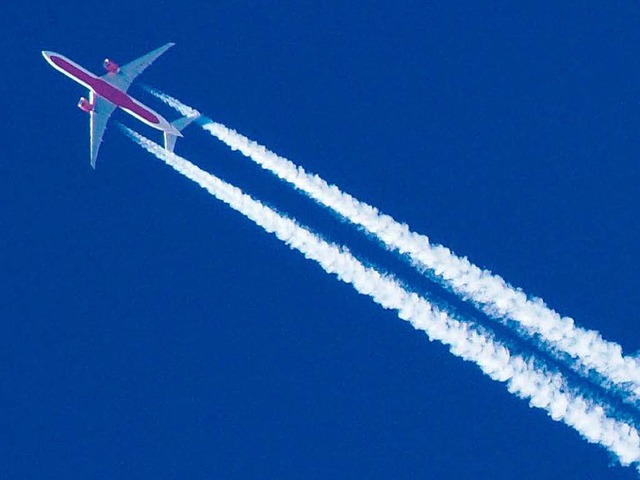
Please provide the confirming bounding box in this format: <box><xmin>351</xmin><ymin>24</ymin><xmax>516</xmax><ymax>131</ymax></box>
<box><xmin>148</xmin><ymin>88</ymin><xmax>640</xmax><ymax>402</ymax></box>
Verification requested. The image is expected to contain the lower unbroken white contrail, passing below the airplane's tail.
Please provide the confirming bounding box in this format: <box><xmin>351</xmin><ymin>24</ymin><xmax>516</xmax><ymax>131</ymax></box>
<box><xmin>122</xmin><ymin>126</ymin><xmax>640</xmax><ymax>466</ymax></box>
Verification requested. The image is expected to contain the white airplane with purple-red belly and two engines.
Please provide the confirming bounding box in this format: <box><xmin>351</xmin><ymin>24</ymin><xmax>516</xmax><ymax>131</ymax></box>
<box><xmin>42</xmin><ymin>43</ymin><xmax>196</xmax><ymax>169</ymax></box>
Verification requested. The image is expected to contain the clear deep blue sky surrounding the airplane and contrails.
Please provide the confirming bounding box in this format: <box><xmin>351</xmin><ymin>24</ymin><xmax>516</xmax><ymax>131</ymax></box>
<box><xmin>0</xmin><ymin>1</ymin><xmax>640</xmax><ymax>479</ymax></box>
